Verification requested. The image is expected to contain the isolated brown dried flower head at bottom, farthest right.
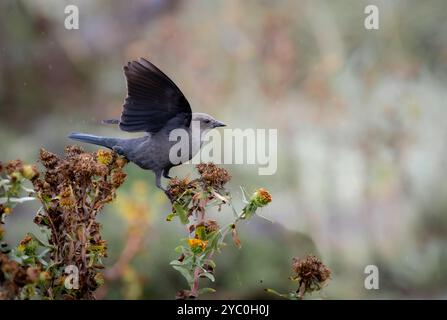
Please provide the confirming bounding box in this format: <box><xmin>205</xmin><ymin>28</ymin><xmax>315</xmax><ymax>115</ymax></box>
<box><xmin>292</xmin><ymin>255</ymin><xmax>331</xmax><ymax>295</ymax></box>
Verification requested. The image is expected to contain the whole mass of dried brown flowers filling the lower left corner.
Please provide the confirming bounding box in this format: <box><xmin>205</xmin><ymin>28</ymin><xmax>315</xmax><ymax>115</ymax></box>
<box><xmin>0</xmin><ymin>146</ymin><xmax>127</xmax><ymax>299</ymax></box>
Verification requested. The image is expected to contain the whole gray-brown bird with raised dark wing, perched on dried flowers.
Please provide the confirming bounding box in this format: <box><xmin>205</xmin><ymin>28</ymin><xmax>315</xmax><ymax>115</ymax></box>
<box><xmin>69</xmin><ymin>58</ymin><xmax>228</xmax><ymax>198</ymax></box>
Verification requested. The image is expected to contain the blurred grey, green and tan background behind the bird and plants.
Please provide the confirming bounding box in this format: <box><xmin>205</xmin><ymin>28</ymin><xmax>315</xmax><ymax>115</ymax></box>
<box><xmin>0</xmin><ymin>0</ymin><xmax>447</xmax><ymax>299</ymax></box>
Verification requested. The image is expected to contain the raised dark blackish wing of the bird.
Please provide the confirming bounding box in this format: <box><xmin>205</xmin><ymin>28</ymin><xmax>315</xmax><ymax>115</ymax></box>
<box><xmin>120</xmin><ymin>58</ymin><xmax>192</xmax><ymax>133</ymax></box>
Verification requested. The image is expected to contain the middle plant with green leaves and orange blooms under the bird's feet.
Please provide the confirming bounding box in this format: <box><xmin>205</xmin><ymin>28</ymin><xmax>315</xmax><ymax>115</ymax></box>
<box><xmin>166</xmin><ymin>163</ymin><xmax>272</xmax><ymax>299</ymax></box>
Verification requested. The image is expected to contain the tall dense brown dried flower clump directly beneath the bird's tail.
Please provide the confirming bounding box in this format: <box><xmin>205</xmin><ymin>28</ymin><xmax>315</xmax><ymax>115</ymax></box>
<box><xmin>27</xmin><ymin>146</ymin><xmax>126</xmax><ymax>299</ymax></box>
